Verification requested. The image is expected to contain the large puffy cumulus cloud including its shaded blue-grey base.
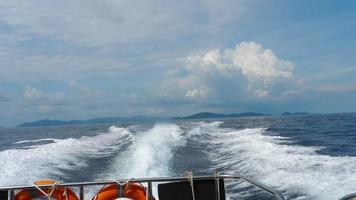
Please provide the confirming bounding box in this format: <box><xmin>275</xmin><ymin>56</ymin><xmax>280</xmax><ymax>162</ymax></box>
<box><xmin>160</xmin><ymin>42</ymin><xmax>300</xmax><ymax>109</ymax></box>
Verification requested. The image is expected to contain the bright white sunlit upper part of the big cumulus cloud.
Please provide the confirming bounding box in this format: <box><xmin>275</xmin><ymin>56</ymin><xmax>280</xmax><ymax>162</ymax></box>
<box><xmin>186</xmin><ymin>42</ymin><xmax>294</xmax><ymax>84</ymax></box>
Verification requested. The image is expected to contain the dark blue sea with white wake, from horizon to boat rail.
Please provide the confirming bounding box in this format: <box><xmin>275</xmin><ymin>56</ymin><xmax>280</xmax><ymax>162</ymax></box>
<box><xmin>0</xmin><ymin>114</ymin><xmax>356</xmax><ymax>200</ymax></box>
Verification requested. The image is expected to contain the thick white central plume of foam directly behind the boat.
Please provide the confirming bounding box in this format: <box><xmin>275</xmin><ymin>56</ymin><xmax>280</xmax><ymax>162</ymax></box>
<box><xmin>101</xmin><ymin>124</ymin><xmax>184</xmax><ymax>178</ymax></box>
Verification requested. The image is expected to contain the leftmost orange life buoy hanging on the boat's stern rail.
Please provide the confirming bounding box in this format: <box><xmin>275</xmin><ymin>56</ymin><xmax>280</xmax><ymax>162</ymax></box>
<box><xmin>14</xmin><ymin>180</ymin><xmax>79</xmax><ymax>200</ymax></box>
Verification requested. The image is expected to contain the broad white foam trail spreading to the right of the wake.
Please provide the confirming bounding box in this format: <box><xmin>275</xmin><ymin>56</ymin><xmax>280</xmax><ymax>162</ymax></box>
<box><xmin>191</xmin><ymin>124</ymin><xmax>356</xmax><ymax>199</ymax></box>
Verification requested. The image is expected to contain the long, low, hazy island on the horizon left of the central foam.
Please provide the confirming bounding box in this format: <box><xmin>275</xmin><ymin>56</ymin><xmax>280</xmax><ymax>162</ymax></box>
<box><xmin>17</xmin><ymin>116</ymin><xmax>168</xmax><ymax>127</ymax></box>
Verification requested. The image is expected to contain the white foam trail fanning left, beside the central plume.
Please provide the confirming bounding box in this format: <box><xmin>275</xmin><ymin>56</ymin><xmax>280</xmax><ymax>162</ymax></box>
<box><xmin>0</xmin><ymin>127</ymin><xmax>131</xmax><ymax>185</ymax></box>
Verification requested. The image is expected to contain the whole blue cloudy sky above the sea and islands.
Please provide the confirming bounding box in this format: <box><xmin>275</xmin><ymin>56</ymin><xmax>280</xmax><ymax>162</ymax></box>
<box><xmin>0</xmin><ymin>0</ymin><xmax>356</xmax><ymax>127</ymax></box>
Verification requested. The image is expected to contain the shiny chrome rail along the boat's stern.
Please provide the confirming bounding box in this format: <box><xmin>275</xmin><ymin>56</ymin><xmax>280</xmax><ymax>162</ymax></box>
<box><xmin>0</xmin><ymin>175</ymin><xmax>285</xmax><ymax>200</ymax></box>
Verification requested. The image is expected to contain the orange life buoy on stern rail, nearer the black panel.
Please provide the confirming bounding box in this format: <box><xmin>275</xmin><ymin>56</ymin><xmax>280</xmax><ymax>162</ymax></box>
<box><xmin>92</xmin><ymin>182</ymin><xmax>155</xmax><ymax>200</ymax></box>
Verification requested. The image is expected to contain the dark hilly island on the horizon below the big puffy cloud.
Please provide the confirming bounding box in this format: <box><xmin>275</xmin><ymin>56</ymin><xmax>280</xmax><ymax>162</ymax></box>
<box><xmin>172</xmin><ymin>112</ymin><xmax>270</xmax><ymax>120</ymax></box>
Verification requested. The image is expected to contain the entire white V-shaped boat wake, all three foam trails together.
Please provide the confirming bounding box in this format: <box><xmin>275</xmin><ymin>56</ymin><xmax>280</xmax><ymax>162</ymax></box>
<box><xmin>0</xmin><ymin>121</ymin><xmax>356</xmax><ymax>199</ymax></box>
